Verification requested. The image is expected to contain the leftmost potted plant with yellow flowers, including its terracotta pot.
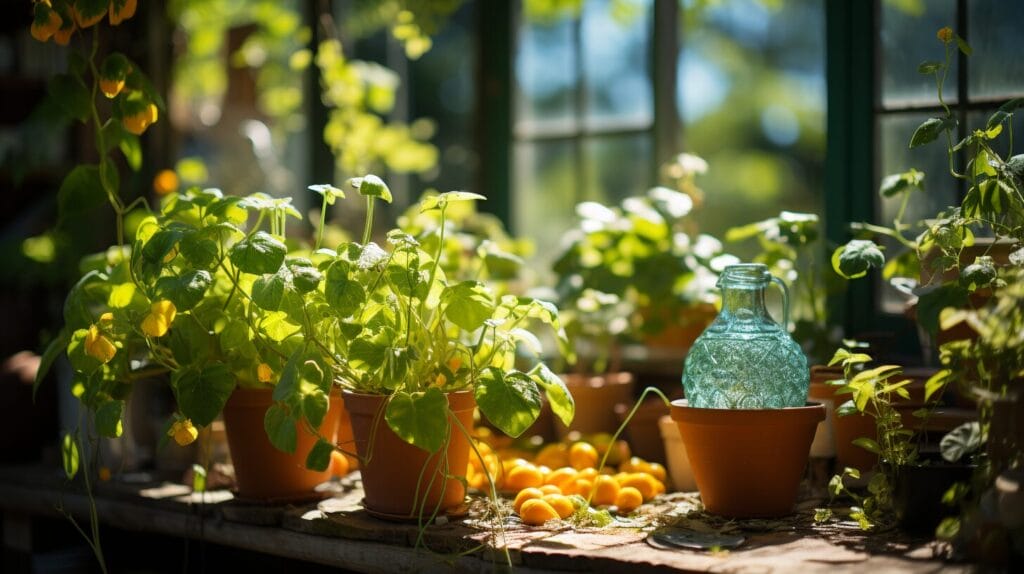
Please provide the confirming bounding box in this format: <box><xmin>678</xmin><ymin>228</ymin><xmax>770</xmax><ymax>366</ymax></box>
<box><xmin>38</xmin><ymin>189</ymin><xmax>341</xmax><ymax>498</ymax></box>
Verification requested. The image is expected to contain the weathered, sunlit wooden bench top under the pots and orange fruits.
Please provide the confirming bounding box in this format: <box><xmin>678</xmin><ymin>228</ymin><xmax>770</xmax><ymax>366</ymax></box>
<box><xmin>0</xmin><ymin>467</ymin><xmax>969</xmax><ymax>573</ymax></box>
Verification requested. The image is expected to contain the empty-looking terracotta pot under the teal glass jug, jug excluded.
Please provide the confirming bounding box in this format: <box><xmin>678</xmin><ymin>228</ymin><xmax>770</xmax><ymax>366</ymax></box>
<box><xmin>672</xmin><ymin>399</ymin><xmax>825</xmax><ymax>518</ymax></box>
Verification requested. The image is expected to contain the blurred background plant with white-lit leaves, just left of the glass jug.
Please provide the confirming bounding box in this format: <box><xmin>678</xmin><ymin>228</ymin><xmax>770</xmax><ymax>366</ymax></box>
<box><xmin>553</xmin><ymin>156</ymin><xmax>735</xmax><ymax>370</ymax></box>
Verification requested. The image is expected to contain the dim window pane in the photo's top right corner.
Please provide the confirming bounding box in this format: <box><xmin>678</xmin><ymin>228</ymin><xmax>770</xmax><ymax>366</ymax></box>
<box><xmin>968</xmin><ymin>0</ymin><xmax>1024</xmax><ymax>97</ymax></box>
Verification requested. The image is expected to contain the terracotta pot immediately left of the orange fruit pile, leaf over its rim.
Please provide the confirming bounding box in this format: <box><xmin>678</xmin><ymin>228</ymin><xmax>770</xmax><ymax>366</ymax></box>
<box><xmin>343</xmin><ymin>391</ymin><xmax>476</xmax><ymax>519</ymax></box>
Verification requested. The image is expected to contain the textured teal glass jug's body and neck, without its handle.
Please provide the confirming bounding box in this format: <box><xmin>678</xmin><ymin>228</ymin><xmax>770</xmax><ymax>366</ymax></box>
<box><xmin>683</xmin><ymin>264</ymin><xmax>810</xmax><ymax>408</ymax></box>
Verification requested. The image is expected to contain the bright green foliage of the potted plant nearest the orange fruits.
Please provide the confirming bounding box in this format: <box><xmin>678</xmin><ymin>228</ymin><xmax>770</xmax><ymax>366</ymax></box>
<box><xmin>272</xmin><ymin>175</ymin><xmax>573</xmax><ymax>460</ymax></box>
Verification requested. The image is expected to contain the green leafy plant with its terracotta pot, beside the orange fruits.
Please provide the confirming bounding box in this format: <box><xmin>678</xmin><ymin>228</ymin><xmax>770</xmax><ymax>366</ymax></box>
<box><xmin>286</xmin><ymin>175</ymin><xmax>573</xmax><ymax>519</ymax></box>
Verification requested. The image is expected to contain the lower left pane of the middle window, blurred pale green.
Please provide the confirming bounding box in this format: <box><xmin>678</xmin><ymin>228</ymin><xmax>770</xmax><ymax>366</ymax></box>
<box><xmin>512</xmin><ymin>141</ymin><xmax>580</xmax><ymax>268</ymax></box>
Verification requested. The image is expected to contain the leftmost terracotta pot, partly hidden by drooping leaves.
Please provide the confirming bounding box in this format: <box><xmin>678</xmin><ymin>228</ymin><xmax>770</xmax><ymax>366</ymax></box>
<box><xmin>224</xmin><ymin>388</ymin><xmax>345</xmax><ymax>501</ymax></box>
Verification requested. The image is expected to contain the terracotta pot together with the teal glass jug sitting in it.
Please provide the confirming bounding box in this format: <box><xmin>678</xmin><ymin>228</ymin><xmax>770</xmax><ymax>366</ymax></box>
<box><xmin>672</xmin><ymin>264</ymin><xmax>824</xmax><ymax>517</ymax></box>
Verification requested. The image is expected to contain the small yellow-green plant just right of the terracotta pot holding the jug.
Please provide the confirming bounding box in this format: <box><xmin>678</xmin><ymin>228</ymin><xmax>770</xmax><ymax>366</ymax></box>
<box><xmin>828</xmin><ymin>348</ymin><xmax>948</xmax><ymax>530</ymax></box>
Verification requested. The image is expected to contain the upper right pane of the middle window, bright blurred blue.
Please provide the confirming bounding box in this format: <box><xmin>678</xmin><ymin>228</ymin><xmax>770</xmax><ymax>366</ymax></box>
<box><xmin>583</xmin><ymin>0</ymin><xmax>654</xmax><ymax>128</ymax></box>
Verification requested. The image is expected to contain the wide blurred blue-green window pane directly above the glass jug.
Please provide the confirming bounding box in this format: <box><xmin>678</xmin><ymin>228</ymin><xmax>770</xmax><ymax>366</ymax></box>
<box><xmin>677</xmin><ymin>0</ymin><xmax>825</xmax><ymax>243</ymax></box>
